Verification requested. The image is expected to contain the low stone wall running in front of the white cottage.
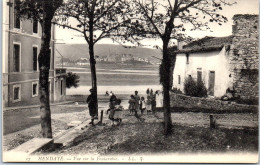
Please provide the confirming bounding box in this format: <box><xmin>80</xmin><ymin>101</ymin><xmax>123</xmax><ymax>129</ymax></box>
<box><xmin>171</xmin><ymin>92</ymin><xmax>258</xmax><ymax>113</ymax></box>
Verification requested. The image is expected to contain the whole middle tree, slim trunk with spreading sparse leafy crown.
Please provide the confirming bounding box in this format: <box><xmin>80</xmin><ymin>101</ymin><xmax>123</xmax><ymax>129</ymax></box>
<box><xmin>56</xmin><ymin>0</ymin><xmax>129</xmax><ymax>113</ymax></box>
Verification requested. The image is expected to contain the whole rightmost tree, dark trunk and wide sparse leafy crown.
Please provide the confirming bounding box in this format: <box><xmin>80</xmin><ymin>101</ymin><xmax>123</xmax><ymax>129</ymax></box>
<box><xmin>125</xmin><ymin>0</ymin><xmax>234</xmax><ymax>135</ymax></box>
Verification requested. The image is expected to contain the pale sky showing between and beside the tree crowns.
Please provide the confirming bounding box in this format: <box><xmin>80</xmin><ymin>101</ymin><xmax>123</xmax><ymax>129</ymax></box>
<box><xmin>55</xmin><ymin>0</ymin><xmax>259</xmax><ymax>48</ymax></box>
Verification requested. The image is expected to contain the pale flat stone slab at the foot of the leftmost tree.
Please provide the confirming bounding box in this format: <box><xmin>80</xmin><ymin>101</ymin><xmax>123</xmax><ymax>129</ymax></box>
<box><xmin>9</xmin><ymin>138</ymin><xmax>53</xmax><ymax>155</ymax></box>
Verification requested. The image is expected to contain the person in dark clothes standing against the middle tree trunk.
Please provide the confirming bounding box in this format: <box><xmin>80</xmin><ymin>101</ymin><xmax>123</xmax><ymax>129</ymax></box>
<box><xmin>86</xmin><ymin>89</ymin><xmax>97</xmax><ymax>126</ymax></box>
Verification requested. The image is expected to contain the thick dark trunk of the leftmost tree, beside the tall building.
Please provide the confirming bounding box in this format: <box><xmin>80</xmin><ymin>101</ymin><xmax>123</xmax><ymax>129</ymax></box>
<box><xmin>38</xmin><ymin>16</ymin><xmax>52</xmax><ymax>138</ymax></box>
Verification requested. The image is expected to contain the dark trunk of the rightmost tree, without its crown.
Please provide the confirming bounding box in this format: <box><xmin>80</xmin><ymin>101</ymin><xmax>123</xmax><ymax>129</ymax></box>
<box><xmin>162</xmin><ymin>40</ymin><xmax>172</xmax><ymax>136</ymax></box>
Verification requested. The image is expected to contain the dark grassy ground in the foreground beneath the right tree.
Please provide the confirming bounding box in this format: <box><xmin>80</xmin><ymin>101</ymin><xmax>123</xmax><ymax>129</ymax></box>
<box><xmin>50</xmin><ymin>111</ymin><xmax>258</xmax><ymax>155</ymax></box>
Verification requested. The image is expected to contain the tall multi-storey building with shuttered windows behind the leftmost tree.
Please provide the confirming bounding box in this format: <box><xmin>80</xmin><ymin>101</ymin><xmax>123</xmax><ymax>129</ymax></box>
<box><xmin>2</xmin><ymin>0</ymin><xmax>65</xmax><ymax>107</ymax></box>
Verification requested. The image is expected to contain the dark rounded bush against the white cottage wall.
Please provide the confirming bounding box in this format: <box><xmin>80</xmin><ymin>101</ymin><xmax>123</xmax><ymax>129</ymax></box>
<box><xmin>184</xmin><ymin>77</ymin><xmax>208</xmax><ymax>97</ymax></box>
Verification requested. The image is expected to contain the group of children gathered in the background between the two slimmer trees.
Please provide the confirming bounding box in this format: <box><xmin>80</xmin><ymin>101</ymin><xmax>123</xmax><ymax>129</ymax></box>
<box><xmin>107</xmin><ymin>89</ymin><xmax>156</xmax><ymax>125</ymax></box>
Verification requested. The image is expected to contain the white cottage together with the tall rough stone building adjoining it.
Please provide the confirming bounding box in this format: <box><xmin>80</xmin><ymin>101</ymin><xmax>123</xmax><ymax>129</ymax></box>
<box><xmin>173</xmin><ymin>15</ymin><xmax>259</xmax><ymax>99</ymax></box>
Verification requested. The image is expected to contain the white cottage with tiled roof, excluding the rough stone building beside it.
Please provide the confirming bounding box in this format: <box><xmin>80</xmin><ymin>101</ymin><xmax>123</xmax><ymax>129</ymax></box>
<box><xmin>173</xmin><ymin>36</ymin><xmax>232</xmax><ymax>97</ymax></box>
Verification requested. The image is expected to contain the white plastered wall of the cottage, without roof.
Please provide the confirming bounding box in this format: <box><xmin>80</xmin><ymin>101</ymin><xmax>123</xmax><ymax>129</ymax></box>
<box><xmin>173</xmin><ymin>48</ymin><xmax>231</xmax><ymax>97</ymax></box>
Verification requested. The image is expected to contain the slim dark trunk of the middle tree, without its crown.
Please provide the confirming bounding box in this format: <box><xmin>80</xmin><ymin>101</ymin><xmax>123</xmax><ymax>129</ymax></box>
<box><xmin>89</xmin><ymin>43</ymin><xmax>98</xmax><ymax>116</ymax></box>
